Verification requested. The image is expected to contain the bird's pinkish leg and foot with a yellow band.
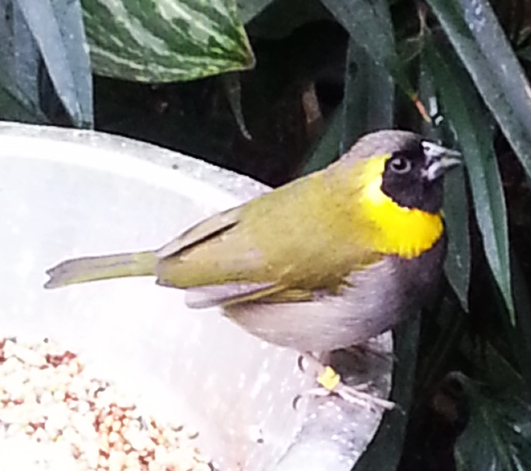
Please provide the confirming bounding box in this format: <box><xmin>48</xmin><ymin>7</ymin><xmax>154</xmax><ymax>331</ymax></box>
<box><xmin>294</xmin><ymin>353</ymin><xmax>394</xmax><ymax>410</ymax></box>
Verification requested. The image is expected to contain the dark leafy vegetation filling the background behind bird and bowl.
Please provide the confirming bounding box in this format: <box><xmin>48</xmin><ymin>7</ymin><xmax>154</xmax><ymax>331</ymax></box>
<box><xmin>0</xmin><ymin>0</ymin><xmax>531</xmax><ymax>471</ymax></box>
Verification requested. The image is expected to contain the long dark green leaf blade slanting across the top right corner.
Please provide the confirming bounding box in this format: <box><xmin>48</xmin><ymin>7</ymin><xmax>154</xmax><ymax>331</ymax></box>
<box><xmin>427</xmin><ymin>0</ymin><xmax>531</xmax><ymax>181</ymax></box>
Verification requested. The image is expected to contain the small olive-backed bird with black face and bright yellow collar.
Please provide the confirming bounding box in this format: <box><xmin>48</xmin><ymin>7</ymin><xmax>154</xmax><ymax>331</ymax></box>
<box><xmin>45</xmin><ymin>130</ymin><xmax>460</xmax><ymax>408</ymax></box>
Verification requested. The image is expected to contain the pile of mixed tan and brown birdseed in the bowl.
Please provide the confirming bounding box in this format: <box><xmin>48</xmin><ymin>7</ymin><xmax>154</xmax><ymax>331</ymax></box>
<box><xmin>0</xmin><ymin>338</ymin><xmax>212</xmax><ymax>471</ymax></box>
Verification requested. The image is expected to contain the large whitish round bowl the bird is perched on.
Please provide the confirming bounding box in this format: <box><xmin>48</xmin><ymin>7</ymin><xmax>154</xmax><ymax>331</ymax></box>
<box><xmin>0</xmin><ymin>123</ymin><xmax>388</xmax><ymax>471</ymax></box>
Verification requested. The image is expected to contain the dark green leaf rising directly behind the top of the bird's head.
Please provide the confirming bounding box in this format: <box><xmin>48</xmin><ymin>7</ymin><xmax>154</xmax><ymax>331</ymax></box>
<box><xmin>341</xmin><ymin>40</ymin><xmax>395</xmax><ymax>153</ymax></box>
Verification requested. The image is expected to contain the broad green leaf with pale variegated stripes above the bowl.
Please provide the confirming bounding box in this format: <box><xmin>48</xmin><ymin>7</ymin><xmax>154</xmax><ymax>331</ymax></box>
<box><xmin>82</xmin><ymin>0</ymin><xmax>254</xmax><ymax>82</ymax></box>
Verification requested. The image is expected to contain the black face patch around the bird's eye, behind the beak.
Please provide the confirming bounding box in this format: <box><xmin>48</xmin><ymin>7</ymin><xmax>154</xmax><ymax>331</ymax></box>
<box><xmin>381</xmin><ymin>141</ymin><xmax>443</xmax><ymax>213</ymax></box>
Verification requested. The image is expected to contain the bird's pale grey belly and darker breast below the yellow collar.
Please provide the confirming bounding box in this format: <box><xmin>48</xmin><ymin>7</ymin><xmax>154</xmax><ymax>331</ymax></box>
<box><xmin>222</xmin><ymin>239</ymin><xmax>446</xmax><ymax>352</ymax></box>
